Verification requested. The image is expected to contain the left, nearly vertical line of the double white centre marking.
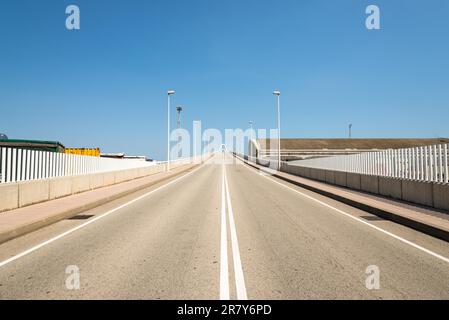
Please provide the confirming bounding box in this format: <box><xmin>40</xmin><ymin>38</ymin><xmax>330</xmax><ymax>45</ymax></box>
<box><xmin>220</xmin><ymin>161</ymin><xmax>229</xmax><ymax>300</ymax></box>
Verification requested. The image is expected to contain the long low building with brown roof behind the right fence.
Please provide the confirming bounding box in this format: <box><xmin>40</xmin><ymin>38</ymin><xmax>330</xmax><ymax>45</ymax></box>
<box><xmin>248</xmin><ymin>138</ymin><xmax>449</xmax><ymax>161</ymax></box>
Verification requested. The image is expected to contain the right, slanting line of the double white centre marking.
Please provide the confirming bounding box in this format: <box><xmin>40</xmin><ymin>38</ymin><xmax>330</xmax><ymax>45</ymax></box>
<box><xmin>224</xmin><ymin>162</ymin><xmax>248</xmax><ymax>300</ymax></box>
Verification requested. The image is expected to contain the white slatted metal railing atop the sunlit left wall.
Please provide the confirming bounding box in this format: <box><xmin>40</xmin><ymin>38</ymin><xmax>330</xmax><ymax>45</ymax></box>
<box><xmin>0</xmin><ymin>148</ymin><xmax>154</xmax><ymax>183</ymax></box>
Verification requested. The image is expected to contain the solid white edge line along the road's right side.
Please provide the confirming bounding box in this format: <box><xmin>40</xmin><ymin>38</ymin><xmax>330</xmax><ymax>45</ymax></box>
<box><xmin>236</xmin><ymin>156</ymin><xmax>449</xmax><ymax>263</ymax></box>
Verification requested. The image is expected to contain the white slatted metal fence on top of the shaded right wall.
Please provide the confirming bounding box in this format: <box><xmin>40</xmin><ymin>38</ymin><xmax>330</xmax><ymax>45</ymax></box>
<box><xmin>295</xmin><ymin>144</ymin><xmax>449</xmax><ymax>184</ymax></box>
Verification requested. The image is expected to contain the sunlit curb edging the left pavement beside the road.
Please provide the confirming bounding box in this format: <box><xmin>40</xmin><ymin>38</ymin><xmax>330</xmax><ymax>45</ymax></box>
<box><xmin>0</xmin><ymin>165</ymin><xmax>197</xmax><ymax>244</ymax></box>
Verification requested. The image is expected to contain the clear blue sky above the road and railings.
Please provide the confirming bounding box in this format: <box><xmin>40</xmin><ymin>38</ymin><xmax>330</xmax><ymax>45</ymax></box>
<box><xmin>0</xmin><ymin>0</ymin><xmax>449</xmax><ymax>159</ymax></box>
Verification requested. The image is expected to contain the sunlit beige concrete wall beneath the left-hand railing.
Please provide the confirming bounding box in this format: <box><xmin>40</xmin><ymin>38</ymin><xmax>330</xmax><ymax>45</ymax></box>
<box><xmin>0</xmin><ymin>155</ymin><xmax>211</xmax><ymax>212</ymax></box>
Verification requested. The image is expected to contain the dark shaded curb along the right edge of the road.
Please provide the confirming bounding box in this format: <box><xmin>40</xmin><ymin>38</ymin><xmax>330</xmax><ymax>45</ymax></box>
<box><xmin>234</xmin><ymin>155</ymin><xmax>449</xmax><ymax>242</ymax></box>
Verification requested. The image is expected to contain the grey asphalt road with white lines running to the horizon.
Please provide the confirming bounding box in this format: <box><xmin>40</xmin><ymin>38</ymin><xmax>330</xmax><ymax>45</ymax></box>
<box><xmin>0</xmin><ymin>154</ymin><xmax>449</xmax><ymax>299</ymax></box>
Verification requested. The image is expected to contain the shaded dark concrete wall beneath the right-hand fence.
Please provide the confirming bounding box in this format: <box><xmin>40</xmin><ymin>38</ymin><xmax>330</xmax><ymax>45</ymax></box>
<box><xmin>281</xmin><ymin>164</ymin><xmax>449</xmax><ymax>211</ymax></box>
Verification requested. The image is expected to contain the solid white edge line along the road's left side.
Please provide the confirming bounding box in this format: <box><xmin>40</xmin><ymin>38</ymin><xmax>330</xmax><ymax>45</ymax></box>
<box><xmin>0</xmin><ymin>161</ymin><xmax>207</xmax><ymax>268</ymax></box>
